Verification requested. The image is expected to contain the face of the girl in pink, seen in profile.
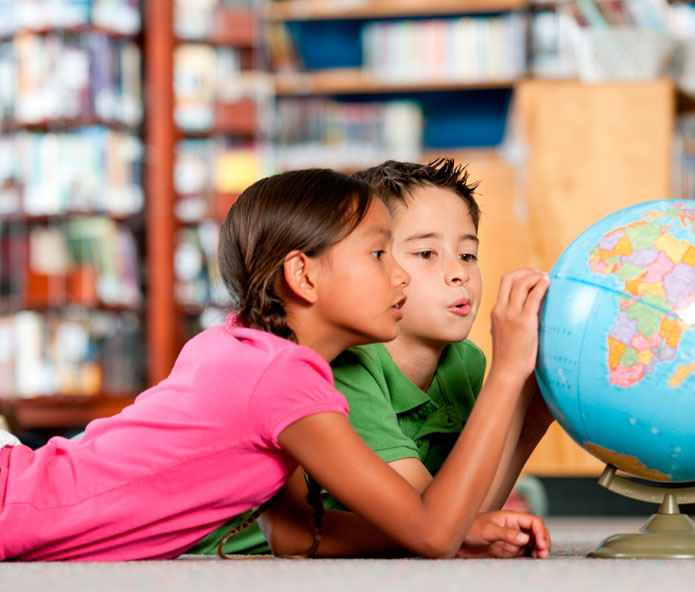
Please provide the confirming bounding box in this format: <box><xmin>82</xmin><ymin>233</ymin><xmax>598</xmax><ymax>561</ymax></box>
<box><xmin>316</xmin><ymin>199</ymin><xmax>410</xmax><ymax>349</ymax></box>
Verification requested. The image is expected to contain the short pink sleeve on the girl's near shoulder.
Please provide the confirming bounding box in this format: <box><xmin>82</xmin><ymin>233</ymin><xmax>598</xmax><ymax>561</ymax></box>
<box><xmin>247</xmin><ymin>347</ymin><xmax>348</xmax><ymax>448</ymax></box>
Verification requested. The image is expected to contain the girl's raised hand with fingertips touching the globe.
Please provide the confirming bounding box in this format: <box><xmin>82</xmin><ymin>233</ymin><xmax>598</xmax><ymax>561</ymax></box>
<box><xmin>490</xmin><ymin>269</ymin><xmax>549</xmax><ymax>381</ymax></box>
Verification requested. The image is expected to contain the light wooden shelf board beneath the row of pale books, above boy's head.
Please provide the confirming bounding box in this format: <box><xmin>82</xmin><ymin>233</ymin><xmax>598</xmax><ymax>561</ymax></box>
<box><xmin>275</xmin><ymin>68</ymin><xmax>517</xmax><ymax>96</ymax></box>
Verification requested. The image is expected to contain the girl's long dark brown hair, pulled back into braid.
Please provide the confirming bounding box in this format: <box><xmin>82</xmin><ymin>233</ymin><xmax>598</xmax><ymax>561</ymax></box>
<box><xmin>218</xmin><ymin>169</ymin><xmax>372</xmax><ymax>341</ymax></box>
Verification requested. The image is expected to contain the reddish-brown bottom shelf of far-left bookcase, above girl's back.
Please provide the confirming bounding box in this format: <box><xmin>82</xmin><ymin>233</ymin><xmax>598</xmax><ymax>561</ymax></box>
<box><xmin>0</xmin><ymin>395</ymin><xmax>135</xmax><ymax>433</ymax></box>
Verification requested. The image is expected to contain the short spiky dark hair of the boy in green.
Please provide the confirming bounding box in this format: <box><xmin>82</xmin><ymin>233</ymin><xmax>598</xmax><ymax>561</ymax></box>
<box><xmin>353</xmin><ymin>158</ymin><xmax>480</xmax><ymax>231</ymax></box>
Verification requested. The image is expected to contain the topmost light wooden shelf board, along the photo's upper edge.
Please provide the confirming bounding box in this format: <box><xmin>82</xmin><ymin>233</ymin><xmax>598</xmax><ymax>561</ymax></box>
<box><xmin>269</xmin><ymin>0</ymin><xmax>529</xmax><ymax>21</ymax></box>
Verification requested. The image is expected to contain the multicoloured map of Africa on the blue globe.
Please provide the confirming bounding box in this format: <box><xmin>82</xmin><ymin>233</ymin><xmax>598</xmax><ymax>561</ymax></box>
<box><xmin>589</xmin><ymin>208</ymin><xmax>695</xmax><ymax>386</ymax></box>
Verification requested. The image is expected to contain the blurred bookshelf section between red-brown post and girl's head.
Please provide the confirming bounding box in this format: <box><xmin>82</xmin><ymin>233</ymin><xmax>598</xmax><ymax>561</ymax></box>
<box><xmin>168</xmin><ymin>0</ymin><xmax>274</xmax><ymax>356</ymax></box>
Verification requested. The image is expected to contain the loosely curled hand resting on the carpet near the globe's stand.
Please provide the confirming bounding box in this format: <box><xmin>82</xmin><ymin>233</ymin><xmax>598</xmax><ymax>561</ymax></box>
<box><xmin>456</xmin><ymin>510</ymin><xmax>550</xmax><ymax>559</ymax></box>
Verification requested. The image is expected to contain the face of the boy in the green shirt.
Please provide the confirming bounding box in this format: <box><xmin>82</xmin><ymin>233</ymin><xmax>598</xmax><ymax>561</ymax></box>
<box><xmin>393</xmin><ymin>185</ymin><xmax>482</xmax><ymax>346</ymax></box>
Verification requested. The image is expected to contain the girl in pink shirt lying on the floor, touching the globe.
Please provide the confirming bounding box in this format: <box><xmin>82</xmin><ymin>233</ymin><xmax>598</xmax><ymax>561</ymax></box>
<box><xmin>0</xmin><ymin>170</ymin><xmax>547</xmax><ymax>560</ymax></box>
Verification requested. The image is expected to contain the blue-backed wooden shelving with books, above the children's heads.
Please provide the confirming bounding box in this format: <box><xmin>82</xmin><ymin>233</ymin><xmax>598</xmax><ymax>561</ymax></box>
<box><xmin>266</xmin><ymin>0</ymin><xmax>528</xmax><ymax>165</ymax></box>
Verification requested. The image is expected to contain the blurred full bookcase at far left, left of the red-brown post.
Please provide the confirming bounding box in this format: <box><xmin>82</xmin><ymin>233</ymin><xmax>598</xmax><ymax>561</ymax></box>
<box><xmin>0</xmin><ymin>0</ymin><xmax>144</xmax><ymax>432</ymax></box>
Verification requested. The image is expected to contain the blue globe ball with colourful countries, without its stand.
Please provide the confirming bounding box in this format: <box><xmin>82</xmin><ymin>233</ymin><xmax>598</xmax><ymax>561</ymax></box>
<box><xmin>536</xmin><ymin>199</ymin><xmax>695</xmax><ymax>482</ymax></box>
